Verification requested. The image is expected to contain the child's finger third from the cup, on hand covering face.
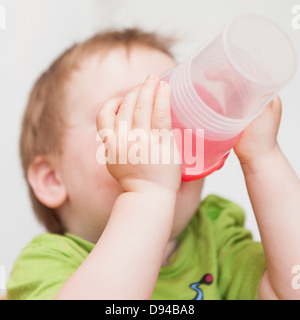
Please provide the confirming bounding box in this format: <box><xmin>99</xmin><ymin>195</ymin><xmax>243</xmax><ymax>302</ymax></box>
<box><xmin>116</xmin><ymin>85</ymin><xmax>141</xmax><ymax>130</ymax></box>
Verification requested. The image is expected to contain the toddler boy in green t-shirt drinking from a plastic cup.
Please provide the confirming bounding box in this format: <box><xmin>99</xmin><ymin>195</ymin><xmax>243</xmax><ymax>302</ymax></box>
<box><xmin>7</xmin><ymin>30</ymin><xmax>300</xmax><ymax>300</ymax></box>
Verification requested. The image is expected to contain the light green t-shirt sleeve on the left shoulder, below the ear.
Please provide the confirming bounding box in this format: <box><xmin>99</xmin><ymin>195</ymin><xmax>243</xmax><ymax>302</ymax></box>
<box><xmin>7</xmin><ymin>235</ymin><xmax>84</xmax><ymax>300</ymax></box>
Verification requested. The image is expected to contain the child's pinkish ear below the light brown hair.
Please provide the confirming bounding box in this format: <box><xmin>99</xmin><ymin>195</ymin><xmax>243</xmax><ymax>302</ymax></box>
<box><xmin>27</xmin><ymin>156</ymin><xmax>67</xmax><ymax>209</ymax></box>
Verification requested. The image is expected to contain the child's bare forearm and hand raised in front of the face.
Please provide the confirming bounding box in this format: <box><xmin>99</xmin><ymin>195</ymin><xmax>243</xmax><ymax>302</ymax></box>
<box><xmin>56</xmin><ymin>77</ymin><xmax>180</xmax><ymax>299</ymax></box>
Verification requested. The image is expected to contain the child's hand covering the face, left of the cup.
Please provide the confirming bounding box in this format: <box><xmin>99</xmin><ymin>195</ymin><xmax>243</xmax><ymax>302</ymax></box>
<box><xmin>97</xmin><ymin>75</ymin><xmax>181</xmax><ymax>192</ymax></box>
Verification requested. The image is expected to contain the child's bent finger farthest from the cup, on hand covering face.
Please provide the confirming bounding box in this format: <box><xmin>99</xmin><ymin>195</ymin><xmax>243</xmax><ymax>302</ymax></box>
<box><xmin>96</xmin><ymin>97</ymin><xmax>123</xmax><ymax>138</ymax></box>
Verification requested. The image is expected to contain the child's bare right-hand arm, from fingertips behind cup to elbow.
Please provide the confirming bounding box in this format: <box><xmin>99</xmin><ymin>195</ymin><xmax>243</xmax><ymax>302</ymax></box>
<box><xmin>235</xmin><ymin>97</ymin><xmax>300</xmax><ymax>299</ymax></box>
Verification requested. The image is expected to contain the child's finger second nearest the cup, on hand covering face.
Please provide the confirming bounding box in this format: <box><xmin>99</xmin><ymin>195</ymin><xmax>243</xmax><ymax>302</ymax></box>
<box><xmin>132</xmin><ymin>75</ymin><xmax>159</xmax><ymax>130</ymax></box>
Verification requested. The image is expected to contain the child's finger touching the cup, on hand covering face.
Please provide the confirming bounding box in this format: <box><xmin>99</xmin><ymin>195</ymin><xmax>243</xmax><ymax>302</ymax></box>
<box><xmin>152</xmin><ymin>81</ymin><xmax>172</xmax><ymax>130</ymax></box>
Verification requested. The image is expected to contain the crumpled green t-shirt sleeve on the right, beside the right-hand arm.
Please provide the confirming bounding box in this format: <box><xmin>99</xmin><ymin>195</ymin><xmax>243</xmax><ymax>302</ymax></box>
<box><xmin>203</xmin><ymin>195</ymin><xmax>266</xmax><ymax>300</ymax></box>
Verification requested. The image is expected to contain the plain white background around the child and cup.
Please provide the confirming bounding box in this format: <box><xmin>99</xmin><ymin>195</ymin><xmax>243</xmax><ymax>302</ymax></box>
<box><xmin>0</xmin><ymin>0</ymin><xmax>300</xmax><ymax>280</ymax></box>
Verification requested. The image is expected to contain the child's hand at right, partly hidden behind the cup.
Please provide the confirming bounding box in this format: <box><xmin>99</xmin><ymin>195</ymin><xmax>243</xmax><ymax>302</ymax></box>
<box><xmin>234</xmin><ymin>96</ymin><xmax>281</xmax><ymax>170</ymax></box>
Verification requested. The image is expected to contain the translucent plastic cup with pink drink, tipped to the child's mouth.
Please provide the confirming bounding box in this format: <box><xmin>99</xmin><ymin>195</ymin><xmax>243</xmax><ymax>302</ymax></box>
<box><xmin>161</xmin><ymin>15</ymin><xmax>297</xmax><ymax>181</ymax></box>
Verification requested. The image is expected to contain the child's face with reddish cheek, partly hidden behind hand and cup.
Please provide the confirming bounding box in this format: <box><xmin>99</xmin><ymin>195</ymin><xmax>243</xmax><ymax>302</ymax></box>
<box><xmin>59</xmin><ymin>47</ymin><xmax>203</xmax><ymax>241</ymax></box>
